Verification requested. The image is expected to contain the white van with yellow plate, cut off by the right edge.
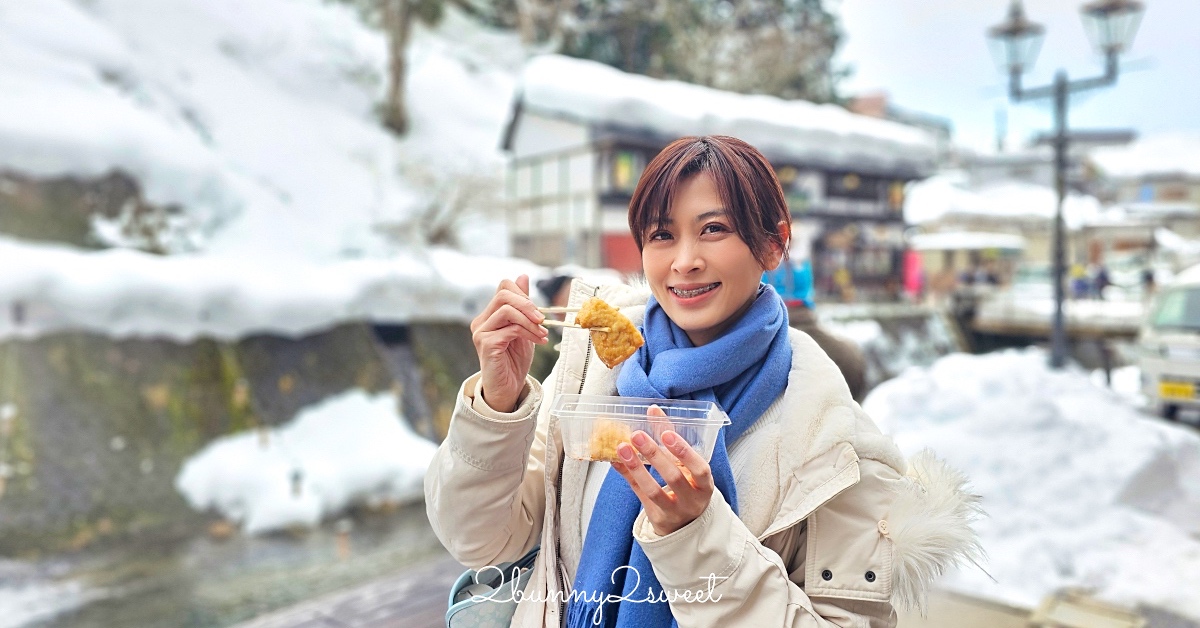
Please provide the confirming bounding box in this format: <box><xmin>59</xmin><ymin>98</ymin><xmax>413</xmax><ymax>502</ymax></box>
<box><xmin>1139</xmin><ymin>267</ymin><xmax>1200</xmax><ymax>419</ymax></box>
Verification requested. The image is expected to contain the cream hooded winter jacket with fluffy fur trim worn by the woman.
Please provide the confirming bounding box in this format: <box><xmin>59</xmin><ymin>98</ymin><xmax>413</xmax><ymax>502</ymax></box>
<box><xmin>425</xmin><ymin>280</ymin><xmax>982</xmax><ymax>628</ymax></box>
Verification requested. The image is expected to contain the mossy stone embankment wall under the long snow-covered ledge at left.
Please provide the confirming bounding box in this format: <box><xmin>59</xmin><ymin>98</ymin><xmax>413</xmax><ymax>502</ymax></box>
<box><xmin>0</xmin><ymin>323</ymin><xmax>478</xmax><ymax>556</ymax></box>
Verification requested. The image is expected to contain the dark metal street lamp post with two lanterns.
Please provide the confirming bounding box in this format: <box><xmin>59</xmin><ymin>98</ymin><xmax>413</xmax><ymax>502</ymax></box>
<box><xmin>988</xmin><ymin>0</ymin><xmax>1144</xmax><ymax>369</ymax></box>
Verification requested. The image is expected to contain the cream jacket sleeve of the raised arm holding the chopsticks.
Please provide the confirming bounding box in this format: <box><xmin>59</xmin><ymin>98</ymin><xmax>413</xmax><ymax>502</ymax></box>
<box><xmin>425</xmin><ymin>373</ymin><xmax>550</xmax><ymax>569</ymax></box>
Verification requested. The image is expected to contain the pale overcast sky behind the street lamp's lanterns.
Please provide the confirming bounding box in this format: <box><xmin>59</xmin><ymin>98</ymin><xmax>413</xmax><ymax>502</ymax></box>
<box><xmin>833</xmin><ymin>0</ymin><xmax>1200</xmax><ymax>150</ymax></box>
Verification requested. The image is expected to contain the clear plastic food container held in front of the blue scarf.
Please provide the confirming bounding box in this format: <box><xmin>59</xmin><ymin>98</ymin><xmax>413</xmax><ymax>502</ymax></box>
<box><xmin>550</xmin><ymin>395</ymin><xmax>730</xmax><ymax>462</ymax></box>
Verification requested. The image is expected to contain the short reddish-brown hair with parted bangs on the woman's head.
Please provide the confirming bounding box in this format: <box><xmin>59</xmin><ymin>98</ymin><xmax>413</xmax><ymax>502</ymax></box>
<box><xmin>629</xmin><ymin>136</ymin><xmax>792</xmax><ymax>267</ymax></box>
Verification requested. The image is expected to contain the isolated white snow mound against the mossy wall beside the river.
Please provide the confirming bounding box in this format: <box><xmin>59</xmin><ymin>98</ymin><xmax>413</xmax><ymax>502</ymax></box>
<box><xmin>175</xmin><ymin>390</ymin><xmax>437</xmax><ymax>533</ymax></box>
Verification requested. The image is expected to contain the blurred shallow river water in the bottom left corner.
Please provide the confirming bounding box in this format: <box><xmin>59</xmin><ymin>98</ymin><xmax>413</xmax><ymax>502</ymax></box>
<box><xmin>0</xmin><ymin>502</ymin><xmax>449</xmax><ymax>628</ymax></box>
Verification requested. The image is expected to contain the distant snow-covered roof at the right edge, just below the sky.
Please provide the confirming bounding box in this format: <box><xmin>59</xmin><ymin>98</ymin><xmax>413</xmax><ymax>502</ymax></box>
<box><xmin>1091</xmin><ymin>133</ymin><xmax>1200</xmax><ymax>179</ymax></box>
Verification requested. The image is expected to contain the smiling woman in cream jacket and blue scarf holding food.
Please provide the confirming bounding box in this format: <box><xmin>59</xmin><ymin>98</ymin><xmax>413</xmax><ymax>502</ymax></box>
<box><xmin>425</xmin><ymin>137</ymin><xmax>979</xmax><ymax>627</ymax></box>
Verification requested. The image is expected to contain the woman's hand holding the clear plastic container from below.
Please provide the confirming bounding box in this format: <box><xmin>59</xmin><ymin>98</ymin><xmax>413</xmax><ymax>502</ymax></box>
<box><xmin>612</xmin><ymin>422</ymin><xmax>714</xmax><ymax>536</ymax></box>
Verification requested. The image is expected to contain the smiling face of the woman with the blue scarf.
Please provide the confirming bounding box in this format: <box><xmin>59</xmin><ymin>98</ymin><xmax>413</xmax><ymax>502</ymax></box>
<box><xmin>642</xmin><ymin>172</ymin><xmax>781</xmax><ymax>347</ymax></box>
